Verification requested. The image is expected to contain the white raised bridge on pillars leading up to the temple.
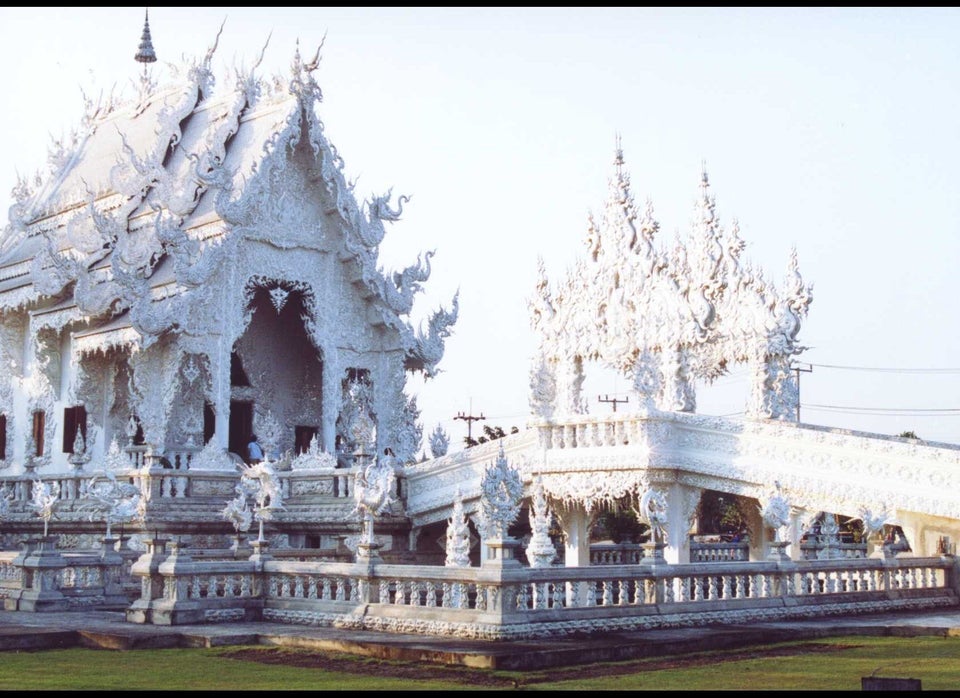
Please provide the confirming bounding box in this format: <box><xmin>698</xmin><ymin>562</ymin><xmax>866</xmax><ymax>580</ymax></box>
<box><xmin>406</xmin><ymin>412</ymin><xmax>960</xmax><ymax>564</ymax></box>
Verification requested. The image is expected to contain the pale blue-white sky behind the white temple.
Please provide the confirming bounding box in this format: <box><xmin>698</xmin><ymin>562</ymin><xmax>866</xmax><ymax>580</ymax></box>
<box><xmin>0</xmin><ymin>7</ymin><xmax>960</xmax><ymax>448</ymax></box>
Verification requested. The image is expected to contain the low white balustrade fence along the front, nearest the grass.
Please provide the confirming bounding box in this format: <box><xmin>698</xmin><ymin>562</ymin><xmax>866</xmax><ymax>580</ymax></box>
<box><xmin>127</xmin><ymin>540</ymin><xmax>958</xmax><ymax>639</ymax></box>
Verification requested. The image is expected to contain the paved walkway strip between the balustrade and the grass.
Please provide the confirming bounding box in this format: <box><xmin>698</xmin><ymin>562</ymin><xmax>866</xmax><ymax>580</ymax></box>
<box><xmin>0</xmin><ymin>609</ymin><xmax>960</xmax><ymax>669</ymax></box>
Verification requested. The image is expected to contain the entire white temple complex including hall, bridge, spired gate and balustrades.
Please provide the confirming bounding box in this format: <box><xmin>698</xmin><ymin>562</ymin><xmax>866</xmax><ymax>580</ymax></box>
<box><xmin>0</xmin><ymin>14</ymin><xmax>960</xmax><ymax>639</ymax></box>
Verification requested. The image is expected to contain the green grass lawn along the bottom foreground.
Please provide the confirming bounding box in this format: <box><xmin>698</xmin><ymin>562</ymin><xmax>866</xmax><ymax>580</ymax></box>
<box><xmin>0</xmin><ymin>636</ymin><xmax>960</xmax><ymax>691</ymax></box>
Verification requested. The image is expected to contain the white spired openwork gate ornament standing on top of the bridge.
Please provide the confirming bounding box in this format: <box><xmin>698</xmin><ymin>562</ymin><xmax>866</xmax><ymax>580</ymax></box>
<box><xmin>529</xmin><ymin>145</ymin><xmax>812</xmax><ymax>419</ymax></box>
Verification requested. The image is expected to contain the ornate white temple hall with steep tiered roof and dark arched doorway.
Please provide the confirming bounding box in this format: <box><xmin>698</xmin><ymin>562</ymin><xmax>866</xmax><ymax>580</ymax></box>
<box><xmin>0</xmin><ymin>32</ymin><xmax>457</xmax><ymax>484</ymax></box>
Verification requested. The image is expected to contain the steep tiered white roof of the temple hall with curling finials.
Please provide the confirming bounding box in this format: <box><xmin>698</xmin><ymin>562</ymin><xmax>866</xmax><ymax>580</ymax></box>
<box><xmin>0</xmin><ymin>31</ymin><xmax>456</xmax><ymax>373</ymax></box>
